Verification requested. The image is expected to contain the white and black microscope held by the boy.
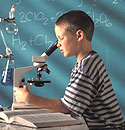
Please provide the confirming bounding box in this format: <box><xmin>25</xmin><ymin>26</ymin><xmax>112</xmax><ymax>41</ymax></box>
<box><xmin>12</xmin><ymin>41</ymin><xmax>58</xmax><ymax>110</ymax></box>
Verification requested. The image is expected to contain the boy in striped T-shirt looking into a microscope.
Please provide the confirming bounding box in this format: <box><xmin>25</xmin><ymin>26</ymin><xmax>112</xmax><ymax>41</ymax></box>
<box><xmin>14</xmin><ymin>10</ymin><xmax>123</xmax><ymax>130</ymax></box>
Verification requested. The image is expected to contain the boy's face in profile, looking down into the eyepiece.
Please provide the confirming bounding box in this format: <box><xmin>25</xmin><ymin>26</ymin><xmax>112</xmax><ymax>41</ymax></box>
<box><xmin>55</xmin><ymin>25</ymin><xmax>77</xmax><ymax>57</ymax></box>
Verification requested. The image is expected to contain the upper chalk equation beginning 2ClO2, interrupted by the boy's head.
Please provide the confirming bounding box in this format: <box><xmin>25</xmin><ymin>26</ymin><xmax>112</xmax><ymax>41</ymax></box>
<box><xmin>19</xmin><ymin>11</ymin><xmax>112</xmax><ymax>27</ymax></box>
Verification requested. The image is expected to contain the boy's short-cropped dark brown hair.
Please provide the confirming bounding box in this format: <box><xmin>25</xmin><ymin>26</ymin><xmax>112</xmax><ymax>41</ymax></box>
<box><xmin>55</xmin><ymin>10</ymin><xmax>94</xmax><ymax>41</ymax></box>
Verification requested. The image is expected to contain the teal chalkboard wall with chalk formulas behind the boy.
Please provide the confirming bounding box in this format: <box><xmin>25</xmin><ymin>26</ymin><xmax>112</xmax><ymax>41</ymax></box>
<box><xmin>0</xmin><ymin>0</ymin><xmax>125</xmax><ymax>118</ymax></box>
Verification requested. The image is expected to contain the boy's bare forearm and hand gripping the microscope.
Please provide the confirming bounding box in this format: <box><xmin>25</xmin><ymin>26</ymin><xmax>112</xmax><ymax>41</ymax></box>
<box><xmin>14</xmin><ymin>85</ymin><xmax>70</xmax><ymax>113</ymax></box>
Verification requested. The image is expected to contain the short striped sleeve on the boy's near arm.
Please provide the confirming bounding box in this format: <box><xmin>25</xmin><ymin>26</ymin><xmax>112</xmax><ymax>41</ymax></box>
<box><xmin>61</xmin><ymin>72</ymin><xmax>96</xmax><ymax>116</ymax></box>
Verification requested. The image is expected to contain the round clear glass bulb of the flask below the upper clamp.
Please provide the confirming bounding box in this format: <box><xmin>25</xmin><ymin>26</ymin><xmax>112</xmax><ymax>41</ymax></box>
<box><xmin>5</xmin><ymin>22</ymin><xmax>18</xmax><ymax>35</ymax></box>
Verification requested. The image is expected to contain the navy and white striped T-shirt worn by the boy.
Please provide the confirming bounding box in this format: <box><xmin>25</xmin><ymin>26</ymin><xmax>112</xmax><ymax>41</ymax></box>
<box><xmin>61</xmin><ymin>51</ymin><xmax>123</xmax><ymax>130</ymax></box>
